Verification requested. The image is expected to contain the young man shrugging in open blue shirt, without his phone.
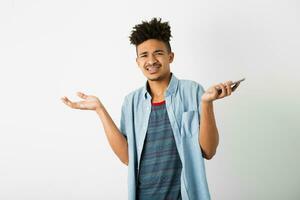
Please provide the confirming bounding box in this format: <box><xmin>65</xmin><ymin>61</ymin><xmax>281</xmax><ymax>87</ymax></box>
<box><xmin>62</xmin><ymin>18</ymin><xmax>239</xmax><ymax>200</ymax></box>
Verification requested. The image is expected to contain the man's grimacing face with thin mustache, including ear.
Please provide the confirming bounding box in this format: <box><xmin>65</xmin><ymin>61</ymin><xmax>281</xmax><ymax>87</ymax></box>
<box><xmin>136</xmin><ymin>39</ymin><xmax>174</xmax><ymax>81</ymax></box>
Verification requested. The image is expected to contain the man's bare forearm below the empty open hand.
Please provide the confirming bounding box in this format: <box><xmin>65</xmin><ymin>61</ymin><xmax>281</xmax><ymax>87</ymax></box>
<box><xmin>96</xmin><ymin>106</ymin><xmax>128</xmax><ymax>165</ymax></box>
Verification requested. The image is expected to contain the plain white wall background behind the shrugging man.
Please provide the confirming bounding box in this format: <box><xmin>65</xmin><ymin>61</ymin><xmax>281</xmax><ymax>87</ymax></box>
<box><xmin>0</xmin><ymin>0</ymin><xmax>300</xmax><ymax>200</ymax></box>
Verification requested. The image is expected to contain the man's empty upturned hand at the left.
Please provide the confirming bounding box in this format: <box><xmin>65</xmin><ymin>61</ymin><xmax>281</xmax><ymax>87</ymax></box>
<box><xmin>61</xmin><ymin>92</ymin><xmax>103</xmax><ymax>110</ymax></box>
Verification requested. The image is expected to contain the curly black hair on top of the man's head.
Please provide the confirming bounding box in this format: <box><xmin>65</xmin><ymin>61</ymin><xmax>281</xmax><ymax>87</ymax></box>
<box><xmin>129</xmin><ymin>18</ymin><xmax>172</xmax><ymax>52</ymax></box>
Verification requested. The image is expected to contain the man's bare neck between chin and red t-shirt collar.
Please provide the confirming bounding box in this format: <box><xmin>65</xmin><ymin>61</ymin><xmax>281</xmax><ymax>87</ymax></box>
<box><xmin>148</xmin><ymin>73</ymin><xmax>171</xmax><ymax>100</ymax></box>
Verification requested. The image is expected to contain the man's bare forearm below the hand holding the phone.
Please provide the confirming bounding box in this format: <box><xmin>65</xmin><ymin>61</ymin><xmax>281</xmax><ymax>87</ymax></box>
<box><xmin>199</xmin><ymin>101</ymin><xmax>219</xmax><ymax>159</ymax></box>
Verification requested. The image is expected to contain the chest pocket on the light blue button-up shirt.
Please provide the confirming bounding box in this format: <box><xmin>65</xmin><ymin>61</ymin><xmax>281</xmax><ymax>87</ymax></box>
<box><xmin>180</xmin><ymin>110</ymin><xmax>200</xmax><ymax>137</ymax></box>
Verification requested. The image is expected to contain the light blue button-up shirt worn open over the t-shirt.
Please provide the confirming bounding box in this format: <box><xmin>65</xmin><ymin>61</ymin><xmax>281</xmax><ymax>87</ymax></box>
<box><xmin>120</xmin><ymin>73</ymin><xmax>210</xmax><ymax>200</ymax></box>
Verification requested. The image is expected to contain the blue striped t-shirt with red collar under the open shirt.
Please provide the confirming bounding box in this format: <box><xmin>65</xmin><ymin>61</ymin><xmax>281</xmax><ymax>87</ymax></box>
<box><xmin>137</xmin><ymin>101</ymin><xmax>182</xmax><ymax>200</ymax></box>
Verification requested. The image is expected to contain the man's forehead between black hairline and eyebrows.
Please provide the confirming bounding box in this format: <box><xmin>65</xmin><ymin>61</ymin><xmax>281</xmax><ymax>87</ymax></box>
<box><xmin>137</xmin><ymin>39</ymin><xmax>167</xmax><ymax>53</ymax></box>
